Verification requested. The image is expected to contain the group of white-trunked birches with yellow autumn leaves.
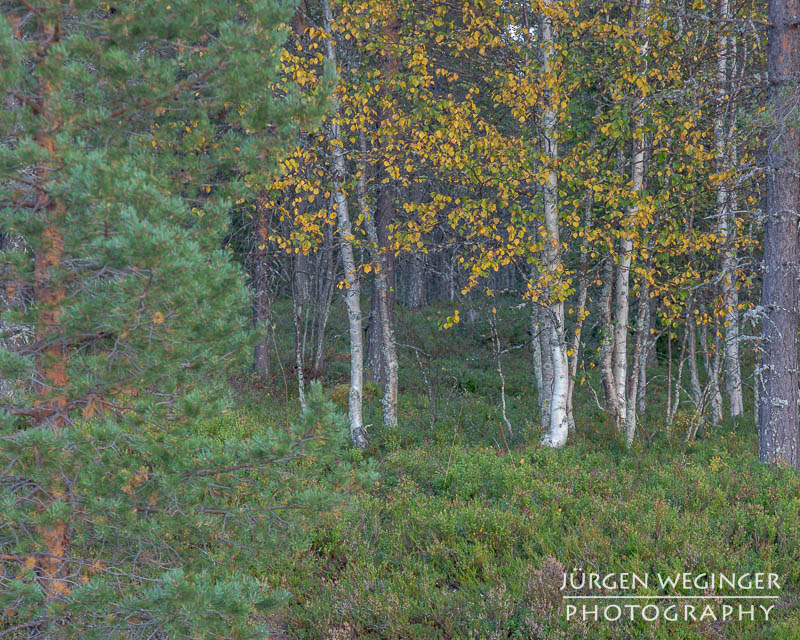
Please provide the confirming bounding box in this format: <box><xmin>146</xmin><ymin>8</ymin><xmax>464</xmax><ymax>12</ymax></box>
<box><xmin>257</xmin><ymin>0</ymin><xmax>797</xmax><ymax>464</ymax></box>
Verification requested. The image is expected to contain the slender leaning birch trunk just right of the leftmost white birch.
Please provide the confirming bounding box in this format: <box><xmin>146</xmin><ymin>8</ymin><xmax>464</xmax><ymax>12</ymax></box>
<box><xmin>358</xmin><ymin>133</ymin><xmax>398</xmax><ymax>429</ymax></box>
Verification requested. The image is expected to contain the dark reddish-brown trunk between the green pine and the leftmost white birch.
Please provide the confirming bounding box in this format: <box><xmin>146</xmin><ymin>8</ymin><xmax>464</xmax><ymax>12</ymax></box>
<box><xmin>252</xmin><ymin>202</ymin><xmax>270</xmax><ymax>380</ymax></box>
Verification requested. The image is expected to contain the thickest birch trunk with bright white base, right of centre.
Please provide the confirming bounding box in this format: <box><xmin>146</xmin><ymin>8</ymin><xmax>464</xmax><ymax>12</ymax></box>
<box><xmin>539</xmin><ymin>0</ymin><xmax>569</xmax><ymax>448</ymax></box>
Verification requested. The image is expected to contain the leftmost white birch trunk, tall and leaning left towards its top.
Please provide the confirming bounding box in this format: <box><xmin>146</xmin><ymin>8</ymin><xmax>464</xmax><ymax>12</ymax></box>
<box><xmin>322</xmin><ymin>0</ymin><xmax>367</xmax><ymax>449</ymax></box>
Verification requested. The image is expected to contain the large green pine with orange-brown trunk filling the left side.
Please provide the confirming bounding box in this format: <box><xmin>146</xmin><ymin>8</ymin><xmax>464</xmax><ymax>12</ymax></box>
<box><xmin>0</xmin><ymin>0</ymin><xmax>334</xmax><ymax>638</ymax></box>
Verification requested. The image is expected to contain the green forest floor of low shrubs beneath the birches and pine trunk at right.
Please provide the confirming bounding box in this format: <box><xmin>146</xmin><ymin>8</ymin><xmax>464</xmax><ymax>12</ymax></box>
<box><xmin>202</xmin><ymin>305</ymin><xmax>800</xmax><ymax>640</ymax></box>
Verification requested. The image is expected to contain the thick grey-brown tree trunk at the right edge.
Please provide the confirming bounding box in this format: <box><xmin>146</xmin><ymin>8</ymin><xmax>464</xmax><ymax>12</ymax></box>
<box><xmin>758</xmin><ymin>0</ymin><xmax>800</xmax><ymax>468</ymax></box>
